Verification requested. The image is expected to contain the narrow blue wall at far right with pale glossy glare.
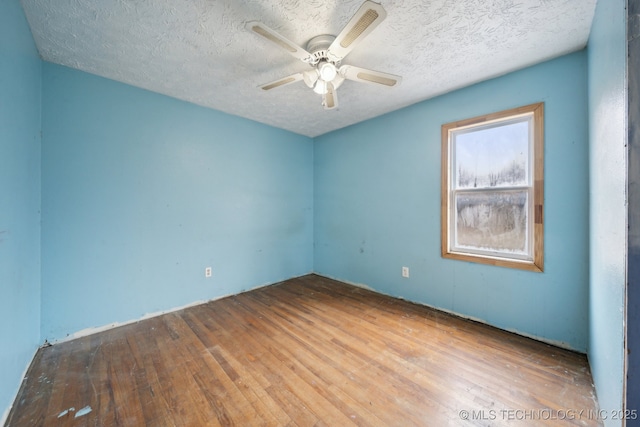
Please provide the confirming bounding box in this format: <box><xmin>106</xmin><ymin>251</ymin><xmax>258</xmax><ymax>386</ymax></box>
<box><xmin>588</xmin><ymin>0</ymin><xmax>628</xmax><ymax>425</ymax></box>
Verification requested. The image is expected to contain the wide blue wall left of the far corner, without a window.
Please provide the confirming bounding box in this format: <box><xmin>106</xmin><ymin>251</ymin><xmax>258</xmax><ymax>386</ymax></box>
<box><xmin>42</xmin><ymin>63</ymin><xmax>313</xmax><ymax>339</ymax></box>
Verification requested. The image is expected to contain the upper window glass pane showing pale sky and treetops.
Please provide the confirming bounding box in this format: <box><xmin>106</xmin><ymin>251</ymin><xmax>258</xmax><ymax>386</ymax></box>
<box><xmin>454</xmin><ymin>119</ymin><xmax>529</xmax><ymax>188</ymax></box>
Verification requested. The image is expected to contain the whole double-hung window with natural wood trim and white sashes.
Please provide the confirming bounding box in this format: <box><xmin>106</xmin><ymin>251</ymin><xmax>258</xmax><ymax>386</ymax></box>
<box><xmin>441</xmin><ymin>103</ymin><xmax>544</xmax><ymax>272</ymax></box>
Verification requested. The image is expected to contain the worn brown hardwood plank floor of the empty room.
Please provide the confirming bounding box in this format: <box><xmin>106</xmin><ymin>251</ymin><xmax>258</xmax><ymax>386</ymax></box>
<box><xmin>7</xmin><ymin>275</ymin><xmax>601</xmax><ymax>426</ymax></box>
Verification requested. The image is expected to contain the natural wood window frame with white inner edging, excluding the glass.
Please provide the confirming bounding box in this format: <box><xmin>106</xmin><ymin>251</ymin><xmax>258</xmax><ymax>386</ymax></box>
<box><xmin>441</xmin><ymin>103</ymin><xmax>544</xmax><ymax>272</ymax></box>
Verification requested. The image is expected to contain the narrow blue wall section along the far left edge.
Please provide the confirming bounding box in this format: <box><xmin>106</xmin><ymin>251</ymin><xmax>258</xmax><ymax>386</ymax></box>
<box><xmin>0</xmin><ymin>0</ymin><xmax>42</xmax><ymax>423</ymax></box>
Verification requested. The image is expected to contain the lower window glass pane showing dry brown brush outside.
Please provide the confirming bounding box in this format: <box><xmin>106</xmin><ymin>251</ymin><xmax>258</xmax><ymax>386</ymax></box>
<box><xmin>455</xmin><ymin>191</ymin><xmax>529</xmax><ymax>255</ymax></box>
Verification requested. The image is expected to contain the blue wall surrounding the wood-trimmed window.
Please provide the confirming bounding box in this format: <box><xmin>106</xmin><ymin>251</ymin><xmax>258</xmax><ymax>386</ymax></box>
<box><xmin>314</xmin><ymin>51</ymin><xmax>589</xmax><ymax>352</ymax></box>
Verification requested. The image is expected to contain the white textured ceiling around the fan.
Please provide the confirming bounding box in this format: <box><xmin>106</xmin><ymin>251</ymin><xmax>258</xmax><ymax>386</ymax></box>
<box><xmin>22</xmin><ymin>0</ymin><xmax>596</xmax><ymax>137</ymax></box>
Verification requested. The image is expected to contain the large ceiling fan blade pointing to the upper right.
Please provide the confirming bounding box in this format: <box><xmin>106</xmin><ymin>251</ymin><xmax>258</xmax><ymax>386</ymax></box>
<box><xmin>327</xmin><ymin>0</ymin><xmax>387</xmax><ymax>62</ymax></box>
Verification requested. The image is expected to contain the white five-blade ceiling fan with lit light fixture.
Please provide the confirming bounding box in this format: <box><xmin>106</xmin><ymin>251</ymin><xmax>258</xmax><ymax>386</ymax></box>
<box><xmin>246</xmin><ymin>0</ymin><xmax>402</xmax><ymax>110</ymax></box>
